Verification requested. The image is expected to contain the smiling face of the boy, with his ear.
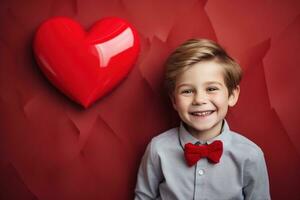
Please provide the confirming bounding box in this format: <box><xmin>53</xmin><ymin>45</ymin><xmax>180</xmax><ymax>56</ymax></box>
<box><xmin>171</xmin><ymin>61</ymin><xmax>239</xmax><ymax>139</ymax></box>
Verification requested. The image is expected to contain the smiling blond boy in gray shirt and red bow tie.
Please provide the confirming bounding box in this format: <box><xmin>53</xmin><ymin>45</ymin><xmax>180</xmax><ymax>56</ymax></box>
<box><xmin>135</xmin><ymin>39</ymin><xmax>270</xmax><ymax>200</ymax></box>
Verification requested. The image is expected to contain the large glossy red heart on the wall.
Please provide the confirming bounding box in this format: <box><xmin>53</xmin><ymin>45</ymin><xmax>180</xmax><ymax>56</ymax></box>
<box><xmin>33</xmin><ymin>17</ymin><xmax>140</xmax><ymax>108</ymax></box>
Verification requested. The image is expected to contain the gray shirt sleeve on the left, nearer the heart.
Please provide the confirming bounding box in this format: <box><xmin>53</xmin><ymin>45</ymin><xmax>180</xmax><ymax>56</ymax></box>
<box><xmin>135</xmin><ymin>140</ymin><xmax>162</xmax><ymax>200</ymax></box>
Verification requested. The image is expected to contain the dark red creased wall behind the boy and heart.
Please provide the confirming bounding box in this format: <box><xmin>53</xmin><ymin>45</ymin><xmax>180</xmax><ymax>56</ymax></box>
<box><xmin>0</xmin><ymin>0</ymin><xmax>300</xmax><ymax>200</ymax></box>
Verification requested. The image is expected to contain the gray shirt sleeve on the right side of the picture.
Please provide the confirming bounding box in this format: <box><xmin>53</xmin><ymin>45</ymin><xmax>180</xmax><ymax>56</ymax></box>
<box><xmin>243</xmin><ymin>149</ymin><xmax>271</xmax><ymax>200</ymax></box>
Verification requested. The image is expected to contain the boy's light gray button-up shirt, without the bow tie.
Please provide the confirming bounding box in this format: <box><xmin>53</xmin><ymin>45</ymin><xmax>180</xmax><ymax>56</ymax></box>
<box><xmin>135</xmin><ymin>120</ymin><xmax>270</xmax><ymax>200</ymax></box>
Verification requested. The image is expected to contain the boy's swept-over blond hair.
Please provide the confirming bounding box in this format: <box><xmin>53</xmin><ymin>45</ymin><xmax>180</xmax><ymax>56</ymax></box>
<box><xmin>165</xmin><ymin>39</ymin><xmax>242</xmax><ymax>95</ymax></box>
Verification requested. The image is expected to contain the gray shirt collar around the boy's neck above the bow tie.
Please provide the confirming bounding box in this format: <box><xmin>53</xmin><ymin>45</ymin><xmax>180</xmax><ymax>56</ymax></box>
<box><xmin>179</xmin><ymin>120</ymin><xmax>231</xmax><ymax>147</ymax></box>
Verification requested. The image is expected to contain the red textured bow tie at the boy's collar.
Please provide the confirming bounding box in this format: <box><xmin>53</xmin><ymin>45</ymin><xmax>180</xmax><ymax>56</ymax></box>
<box><xmin>184</xmin><ymin>140</ymin><xmax>223</xmax><ymax>167</ymax></box>
